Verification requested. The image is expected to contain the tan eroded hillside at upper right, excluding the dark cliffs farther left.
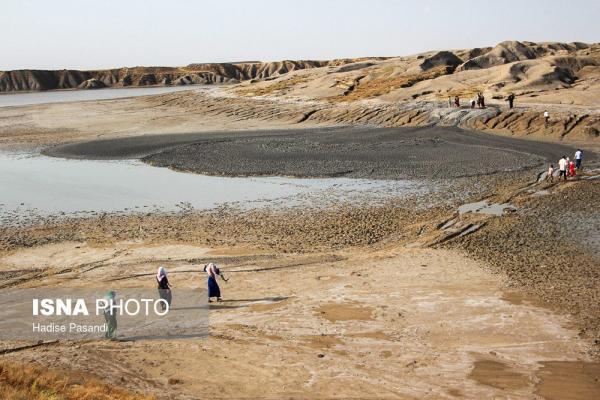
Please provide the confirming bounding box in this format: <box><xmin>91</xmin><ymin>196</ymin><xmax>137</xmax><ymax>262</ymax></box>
<box><xmin>235</xmin><ymin>41</ymin><xmax>600</xmax><ymax>105</ymax></box>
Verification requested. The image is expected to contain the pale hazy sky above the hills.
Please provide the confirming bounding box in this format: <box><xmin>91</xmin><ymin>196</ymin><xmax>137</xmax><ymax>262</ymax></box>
<box><xmin>0</xmin><ymin>0</ymin><xmax>600</xmax><ymax>70</ymax></box>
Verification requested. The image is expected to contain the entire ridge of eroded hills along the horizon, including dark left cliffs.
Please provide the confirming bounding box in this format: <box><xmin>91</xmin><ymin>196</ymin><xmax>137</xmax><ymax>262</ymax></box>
<box><xmin>0</xmin><ymin>41</ymin><xmax>600</xmax><ymax>105</ymax></box>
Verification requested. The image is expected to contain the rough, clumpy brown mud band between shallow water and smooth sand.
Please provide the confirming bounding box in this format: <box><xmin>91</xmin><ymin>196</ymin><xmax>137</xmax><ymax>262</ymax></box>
<box><xmin>0</xmin><ymin>166</ymin><xmax>600</xmax><ymax>346</ymax></box>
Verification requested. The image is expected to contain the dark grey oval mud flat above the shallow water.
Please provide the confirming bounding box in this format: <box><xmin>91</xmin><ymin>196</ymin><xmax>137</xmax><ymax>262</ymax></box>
<box><xmin>46</xmin><ymin>127</ymin><xmax>573</xmax><ymax>179</ymax></box>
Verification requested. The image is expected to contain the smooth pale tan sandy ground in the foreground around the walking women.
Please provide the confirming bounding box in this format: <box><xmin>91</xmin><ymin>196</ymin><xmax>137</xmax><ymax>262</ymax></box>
<box><xmin>1</xmin><ymin>239</ymin><xmax>600</xmax><ymax>399</ymax></box>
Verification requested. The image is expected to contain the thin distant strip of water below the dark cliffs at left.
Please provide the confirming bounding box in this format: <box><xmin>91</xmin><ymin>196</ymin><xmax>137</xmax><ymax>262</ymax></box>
<box><xmin>0</xmin><ymin>85</ymin><xmax>204</xmax><ymax>107</ymax></box>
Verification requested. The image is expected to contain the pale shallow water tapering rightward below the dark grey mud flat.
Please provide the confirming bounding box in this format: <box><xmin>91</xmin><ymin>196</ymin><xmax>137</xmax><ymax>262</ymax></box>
<box><xmin>0</xmin><ymin>153</ymin><xmax>426</xmax><ymax>224</ymax></box>
